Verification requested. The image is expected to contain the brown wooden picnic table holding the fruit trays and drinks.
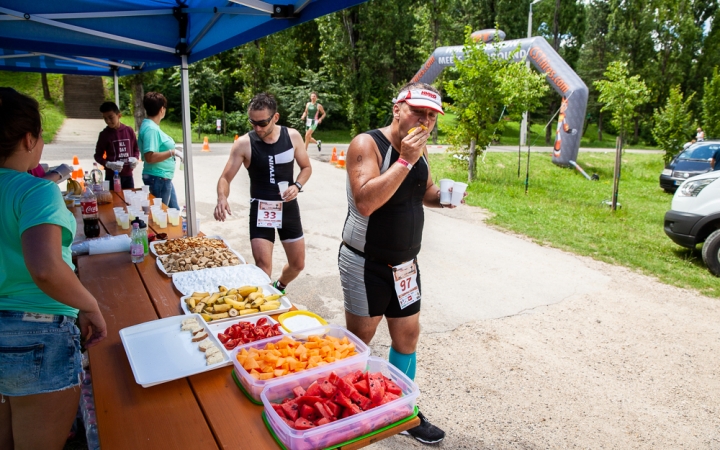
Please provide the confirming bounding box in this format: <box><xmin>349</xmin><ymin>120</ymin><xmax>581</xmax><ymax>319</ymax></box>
<box><xmin>74</xmin><ymin>193</ymin><xmax>420</xmax><ymax>450</ymax></box>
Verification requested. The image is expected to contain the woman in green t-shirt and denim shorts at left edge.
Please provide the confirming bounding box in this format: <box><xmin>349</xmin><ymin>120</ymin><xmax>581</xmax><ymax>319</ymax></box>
<box><xmin>0</xmin><ymin>87</ymin><xmax>107</xmax><ymax>449</ymax></box>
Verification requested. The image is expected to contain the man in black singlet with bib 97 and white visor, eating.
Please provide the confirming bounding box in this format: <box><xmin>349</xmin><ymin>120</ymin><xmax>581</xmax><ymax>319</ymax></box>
<box><xmin>338</xmin><ymin>83</ymin><xmax>462</xmax><ymax>444</ymax></box>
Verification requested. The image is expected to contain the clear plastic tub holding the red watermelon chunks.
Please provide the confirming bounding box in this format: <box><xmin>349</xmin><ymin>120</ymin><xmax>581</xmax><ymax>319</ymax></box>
<box><xmin>260</xmin><ymin>356</ymin><xmax>420</xmax><ymax>450</ymax></box>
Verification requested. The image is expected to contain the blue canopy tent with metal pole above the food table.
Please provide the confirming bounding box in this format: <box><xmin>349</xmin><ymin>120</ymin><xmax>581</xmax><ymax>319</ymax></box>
<box><xmin>0</xmin><ymin>0</ymin><xmax>366</xmax><ymax>236</ymax></box>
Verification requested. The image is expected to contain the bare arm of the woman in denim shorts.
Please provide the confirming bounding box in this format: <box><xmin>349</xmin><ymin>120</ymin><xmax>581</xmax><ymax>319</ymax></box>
<box><xmin>22</xmin><ymin>224</ymin><xmax>107</xmax><ymax>347</ymax></box>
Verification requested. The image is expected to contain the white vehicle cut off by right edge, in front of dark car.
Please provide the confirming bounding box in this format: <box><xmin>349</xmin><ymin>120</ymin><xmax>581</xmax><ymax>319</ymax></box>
<box><xmin>665</xmin><ymin>171</ymin><xmax>720</xmax><ymax>276</ymax></box>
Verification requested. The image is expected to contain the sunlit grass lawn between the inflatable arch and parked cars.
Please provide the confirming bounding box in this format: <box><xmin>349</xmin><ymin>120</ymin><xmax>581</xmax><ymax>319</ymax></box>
<box><xmin>430</xmin><ymin>152</ymin><xmax>720</xmax><ymax>297</ymax></box>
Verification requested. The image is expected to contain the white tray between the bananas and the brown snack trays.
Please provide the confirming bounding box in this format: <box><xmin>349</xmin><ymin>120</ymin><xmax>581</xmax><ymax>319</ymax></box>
<box><xmin>172</xmin><ymin>264</ymin><xmax>272</xmax><ymax>295</ymax></box>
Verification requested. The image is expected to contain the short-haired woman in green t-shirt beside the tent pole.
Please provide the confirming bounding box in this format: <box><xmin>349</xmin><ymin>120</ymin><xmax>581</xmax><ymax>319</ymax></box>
<box><xmin>138</xmin><ymin>92</ymin><xmax>183</xmax><ymax>208</ymax></box>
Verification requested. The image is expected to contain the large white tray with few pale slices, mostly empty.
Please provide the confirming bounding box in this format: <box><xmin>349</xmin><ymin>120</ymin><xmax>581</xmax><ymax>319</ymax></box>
<box><xmin>120</xmin><ymin>314</ymin><xmax>232</xmax><ymax>387</ymax></box>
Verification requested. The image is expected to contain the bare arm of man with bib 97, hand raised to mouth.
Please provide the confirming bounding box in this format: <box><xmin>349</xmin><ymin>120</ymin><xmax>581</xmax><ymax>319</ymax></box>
<box><xmin>347</xmin><ymin>127</ymin><xmax>429</xmax><ymax>216</ymax></box>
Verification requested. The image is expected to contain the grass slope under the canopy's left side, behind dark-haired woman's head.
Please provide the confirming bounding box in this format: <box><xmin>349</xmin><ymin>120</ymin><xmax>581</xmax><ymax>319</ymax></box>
<box><xmin>0</xmin><ymin>70</ymin><xmax>65</xmax><ymax>142</ymax></box>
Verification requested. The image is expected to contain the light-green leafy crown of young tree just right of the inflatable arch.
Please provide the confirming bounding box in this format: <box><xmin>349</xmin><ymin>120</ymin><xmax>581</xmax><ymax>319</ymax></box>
<box><xmin>594</xmin><ymin>61</ymin><xmax>650</xmax><ymax>145</ymax></box>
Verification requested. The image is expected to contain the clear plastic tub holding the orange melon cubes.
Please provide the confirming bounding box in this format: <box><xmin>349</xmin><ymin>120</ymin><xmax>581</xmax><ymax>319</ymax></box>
<box><xmin>230</xmin><ymin>325</ymin><xmax>370</xmax><ymax>404</ymax></box>
